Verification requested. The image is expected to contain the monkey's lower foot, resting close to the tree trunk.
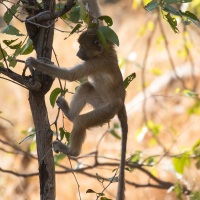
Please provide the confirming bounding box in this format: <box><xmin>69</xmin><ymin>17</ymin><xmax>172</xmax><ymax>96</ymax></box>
<box><xmin>52</xmin><ymin>140</ymin><xmax>79</xmax><ymax>156</ymax></box>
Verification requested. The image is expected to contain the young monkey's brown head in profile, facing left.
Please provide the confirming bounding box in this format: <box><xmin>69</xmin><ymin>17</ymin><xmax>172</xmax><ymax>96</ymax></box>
<box><xmin>76</xmin><ymin>30</ymin><xmax>111</xmax><ymax>61</ymax></box>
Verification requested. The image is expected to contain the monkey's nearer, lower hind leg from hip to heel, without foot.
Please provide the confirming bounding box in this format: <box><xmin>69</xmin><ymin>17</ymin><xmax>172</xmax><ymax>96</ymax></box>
<box><xmin>68</xmin><ymin>100</ymin><xmax>123</xmax><ymax>155</ymax></box>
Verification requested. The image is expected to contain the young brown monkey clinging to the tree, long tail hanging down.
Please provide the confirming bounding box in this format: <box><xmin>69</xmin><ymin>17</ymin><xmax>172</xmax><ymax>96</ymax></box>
<box><xmin>25</xmin><ymin>0</ymin><xmax>128</xmax><ymax>200</ymax></box>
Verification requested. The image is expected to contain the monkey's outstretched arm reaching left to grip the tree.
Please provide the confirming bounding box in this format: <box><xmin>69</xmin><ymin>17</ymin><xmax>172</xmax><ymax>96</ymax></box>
<box><xmin>26</xmin><ymin>57</ymin><xmax>99</xmax><ymax>81</ymax></box>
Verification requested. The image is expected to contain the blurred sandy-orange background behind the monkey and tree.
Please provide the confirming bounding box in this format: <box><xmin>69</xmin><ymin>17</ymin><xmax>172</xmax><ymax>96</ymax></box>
<box><xmin>0</xmin><ymin>0</ymin><xmax>200</xmax><ymax>200</ymax></box>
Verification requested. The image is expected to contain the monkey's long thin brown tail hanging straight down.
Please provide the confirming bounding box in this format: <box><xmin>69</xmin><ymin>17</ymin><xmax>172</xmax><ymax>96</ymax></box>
<box><xmin>117</xmin><ymin>105</ymin><xmax>128</xmax><ymax>200</ymax></box>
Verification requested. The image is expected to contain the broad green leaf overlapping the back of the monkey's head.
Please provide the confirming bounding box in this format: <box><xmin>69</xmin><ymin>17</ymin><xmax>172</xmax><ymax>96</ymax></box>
<box><xmin>97</xmin><ymin>26</ymin><xmax>119</xmax><ymax>46</ymax></box>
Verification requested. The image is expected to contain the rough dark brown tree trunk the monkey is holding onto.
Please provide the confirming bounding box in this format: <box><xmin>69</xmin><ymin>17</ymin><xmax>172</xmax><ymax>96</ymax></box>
<box><xmin>29</xmin><ymin>0</ymin><xmax>56</xmax><ymax>200</ymax></box>
